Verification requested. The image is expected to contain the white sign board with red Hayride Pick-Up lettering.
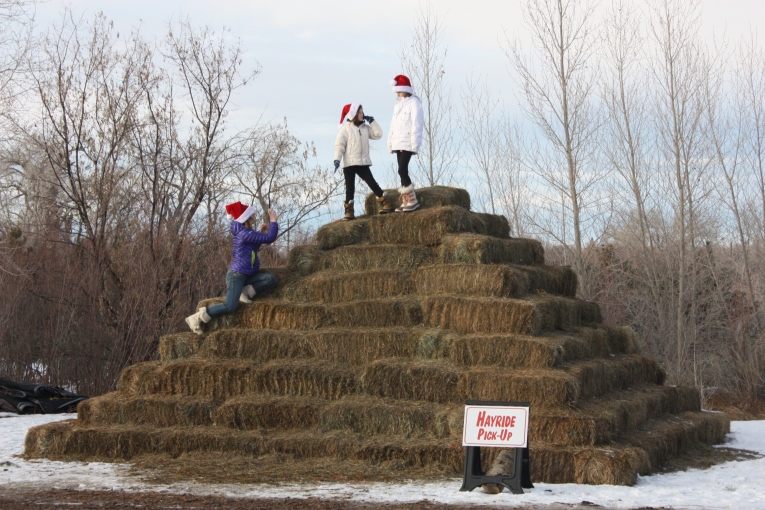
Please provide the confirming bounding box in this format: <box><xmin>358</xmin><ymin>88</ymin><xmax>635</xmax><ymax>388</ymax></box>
<box><xmin>462</xmin><ymin>405</ymin><xmax>529</xmax><ymax>448</ymax></box>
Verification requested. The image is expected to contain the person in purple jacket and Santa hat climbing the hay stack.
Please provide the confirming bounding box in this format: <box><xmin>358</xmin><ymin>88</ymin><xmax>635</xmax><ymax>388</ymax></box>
<box><xmin>186</xmin><ymin>202</ymin><xmax>279</xmax><ymax>335</ymax></box>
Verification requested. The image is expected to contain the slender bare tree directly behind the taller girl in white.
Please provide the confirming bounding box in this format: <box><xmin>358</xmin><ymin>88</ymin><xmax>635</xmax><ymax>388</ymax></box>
<box><xmin>401</xmin><ymin>1</ymin><xmax>457</xmax><ymax>186</ymax></box>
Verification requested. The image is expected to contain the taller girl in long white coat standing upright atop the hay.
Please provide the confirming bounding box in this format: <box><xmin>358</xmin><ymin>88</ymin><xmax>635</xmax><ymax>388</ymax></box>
<box><xmin>388</xmin><ymin>74</ymin><xmax>424</xmax><ymax>212</ymax></box>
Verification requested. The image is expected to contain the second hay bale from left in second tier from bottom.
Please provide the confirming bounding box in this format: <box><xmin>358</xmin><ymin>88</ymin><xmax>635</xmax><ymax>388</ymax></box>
<box><xmin>215</xmin><ymin>395</ymin><xmax>326</xmax><ymax>430</ymax></box>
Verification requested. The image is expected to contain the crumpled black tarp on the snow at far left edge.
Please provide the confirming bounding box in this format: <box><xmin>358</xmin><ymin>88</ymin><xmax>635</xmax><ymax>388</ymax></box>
<box><xmin>0</xmin><ymin>377</ymin><xmax>88</xmax><ymax>414</ymax></box>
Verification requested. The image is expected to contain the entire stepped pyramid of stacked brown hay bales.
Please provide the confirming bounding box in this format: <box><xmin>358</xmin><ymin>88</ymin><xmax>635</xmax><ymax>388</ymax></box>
<box><xmin>26</xmin><ymin>187</ymin><xmax>730</xmax><ymax>484</ymax></box>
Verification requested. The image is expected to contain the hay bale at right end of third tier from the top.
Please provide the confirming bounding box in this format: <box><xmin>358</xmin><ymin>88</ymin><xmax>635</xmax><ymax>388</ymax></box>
<box><xmin>438</xmin><ymin>232</ymin><xmax>545</xmax><ymax>266</ymax></box>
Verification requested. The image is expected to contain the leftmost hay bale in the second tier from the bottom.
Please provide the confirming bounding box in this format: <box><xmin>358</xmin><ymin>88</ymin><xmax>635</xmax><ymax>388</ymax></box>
<box><xmin>77</xmin><ymin>391</ymin><xmax>218</xmax><ymax>427</ymax></box>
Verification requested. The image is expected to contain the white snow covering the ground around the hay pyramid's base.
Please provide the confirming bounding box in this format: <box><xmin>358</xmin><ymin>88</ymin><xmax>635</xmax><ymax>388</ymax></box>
<box><xmin>0</xmin><ymin>413</ymin><xmax>765</xmax><ymax>510</ymax></box>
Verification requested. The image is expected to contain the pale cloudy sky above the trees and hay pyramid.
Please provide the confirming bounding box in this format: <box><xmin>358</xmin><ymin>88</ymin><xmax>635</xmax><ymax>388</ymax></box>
<box><xmin>37</xmin><ymin>0</ymin><xmax>765</xmax><ymax>185</ymax></box>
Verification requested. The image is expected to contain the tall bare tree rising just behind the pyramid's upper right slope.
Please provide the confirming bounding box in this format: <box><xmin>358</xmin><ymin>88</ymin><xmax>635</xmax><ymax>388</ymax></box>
<box><xmin>505</xmin><ymin>0</ymin><xmax>598</xmax><ymax>275</ymax></box>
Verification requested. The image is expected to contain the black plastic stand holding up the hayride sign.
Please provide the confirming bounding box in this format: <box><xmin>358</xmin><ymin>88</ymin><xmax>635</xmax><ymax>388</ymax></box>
<box><xmin>460</xmin><ymin>400</ymin><xmax>534</xmax><ymax>494</ymax></box>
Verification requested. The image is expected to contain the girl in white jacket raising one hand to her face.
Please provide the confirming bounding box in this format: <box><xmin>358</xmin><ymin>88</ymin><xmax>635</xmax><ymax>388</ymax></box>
<box><xmin>334</xmin><ymin>103</ymin><xmax>393</xmax><ymax>221</ymax></box>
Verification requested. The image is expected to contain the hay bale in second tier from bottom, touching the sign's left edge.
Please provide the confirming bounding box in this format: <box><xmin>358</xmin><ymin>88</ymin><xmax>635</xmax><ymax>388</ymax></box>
<box><xmin>320</xmin><ymin>395</ymin><xmax>464</xmax><ymax>438</ymax></box>
